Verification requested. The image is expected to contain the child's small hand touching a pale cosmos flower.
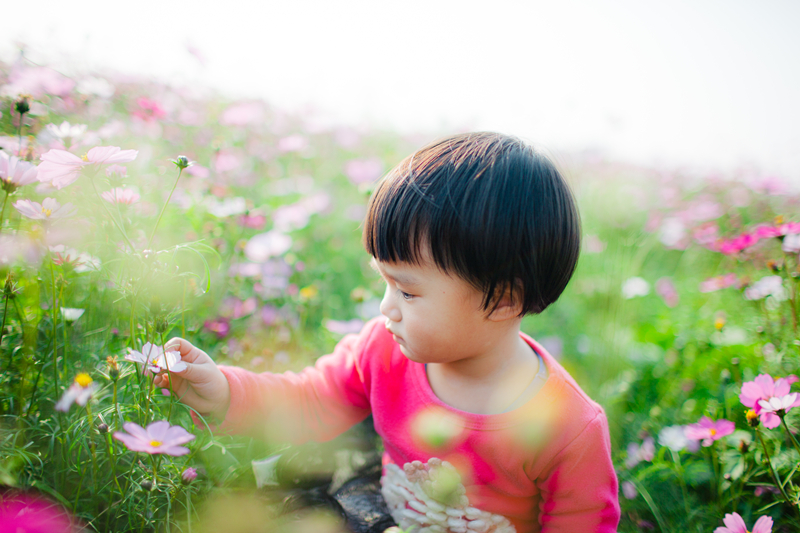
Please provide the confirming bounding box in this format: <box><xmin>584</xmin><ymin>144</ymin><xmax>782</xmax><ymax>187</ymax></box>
<box><xmin>154</xmin><ymin>337</ymin><xmax>231</xmax><ymax>420</ymax></box>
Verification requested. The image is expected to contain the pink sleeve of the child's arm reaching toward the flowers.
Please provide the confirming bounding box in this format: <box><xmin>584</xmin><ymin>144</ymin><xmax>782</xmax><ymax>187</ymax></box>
<box><xmin>209</xmin><ymin>324</ymin><xmax>374</xmax><ymax>444</ymax></box>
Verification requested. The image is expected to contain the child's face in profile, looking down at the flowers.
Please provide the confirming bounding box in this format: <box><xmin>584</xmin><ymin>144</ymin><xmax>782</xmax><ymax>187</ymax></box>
<box><xmin>372</xmin><ymin>250</ymin><xmax>504</xmax><ymax>363</ymax></box>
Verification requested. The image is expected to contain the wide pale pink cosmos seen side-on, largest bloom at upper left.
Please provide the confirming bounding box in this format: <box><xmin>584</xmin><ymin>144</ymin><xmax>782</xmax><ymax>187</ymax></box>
<box><xmin>38</xmin><ymin>146</ymin><xmax>139</xmax><ymax>189</ymax></box>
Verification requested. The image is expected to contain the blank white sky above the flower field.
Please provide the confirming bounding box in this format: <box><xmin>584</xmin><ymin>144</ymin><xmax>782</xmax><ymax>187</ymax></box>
<box><xmin>6</xmin><ymin>0</ymin><xmax>800</xmax><ymax>177</ymax></box>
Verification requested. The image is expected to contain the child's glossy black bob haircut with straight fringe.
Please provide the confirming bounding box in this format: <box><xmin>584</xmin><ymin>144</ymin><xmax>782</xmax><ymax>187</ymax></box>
<box><xmin>363</xmin><ymin>132</ymin><xmax>581</xmax><ymax>316</ymax></box>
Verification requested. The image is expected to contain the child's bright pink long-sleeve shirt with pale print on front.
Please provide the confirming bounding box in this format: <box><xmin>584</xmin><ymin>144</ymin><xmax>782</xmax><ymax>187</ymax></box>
<box><xmin>220</xmin><ymin>320</ymin><xmax>619</xmax><ymax>533</ymax></box>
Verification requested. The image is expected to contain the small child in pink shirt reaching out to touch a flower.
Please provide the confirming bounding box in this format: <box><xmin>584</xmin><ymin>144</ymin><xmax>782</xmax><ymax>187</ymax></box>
<box><xmin>156</xmin><ymin>133</ymin><xmax>619</xmax><ymax>533</ymax></box>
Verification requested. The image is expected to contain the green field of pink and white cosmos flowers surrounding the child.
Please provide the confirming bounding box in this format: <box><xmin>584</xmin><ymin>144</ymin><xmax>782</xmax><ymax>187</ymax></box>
<box><xmin>0</xmin><ymin>61</ymin><xmax>800</xmax><ymax>533</ymax></box>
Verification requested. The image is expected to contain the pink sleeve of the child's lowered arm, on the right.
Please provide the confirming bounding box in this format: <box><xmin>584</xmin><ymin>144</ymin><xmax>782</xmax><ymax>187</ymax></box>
<box><xmin>537</xmin><ymin>411</ymin><xmax>620</xmax><ymax>533</ymax></box>
